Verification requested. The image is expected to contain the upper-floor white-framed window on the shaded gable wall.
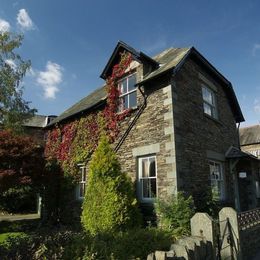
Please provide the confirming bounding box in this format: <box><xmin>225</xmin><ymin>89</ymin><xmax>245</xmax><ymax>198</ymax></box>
<box><xmin>202</xmin><ymin>85</ymin><xmax>218</xmax><ymax>118</ymax></box>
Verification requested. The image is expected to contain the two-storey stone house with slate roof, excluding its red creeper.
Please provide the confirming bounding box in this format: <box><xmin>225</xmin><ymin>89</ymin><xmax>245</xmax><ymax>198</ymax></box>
<box><xmin>47</xmin><ymin>42</ymin><xmax>258</xmax><ymax>213</ymax></box>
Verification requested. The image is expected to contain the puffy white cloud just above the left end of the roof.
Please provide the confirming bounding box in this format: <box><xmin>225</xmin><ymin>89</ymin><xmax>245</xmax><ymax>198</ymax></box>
<box><xmin>36</xmin><ymin>61</ymin><xmax>63</xmax><ymax>99</ymax></box>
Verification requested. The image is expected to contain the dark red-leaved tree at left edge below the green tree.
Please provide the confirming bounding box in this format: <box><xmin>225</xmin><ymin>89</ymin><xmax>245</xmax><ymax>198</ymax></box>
<box><xmin>0</xmin><ymin>130</ymin><xmax>44</xmax><ymax>212</ymax></box>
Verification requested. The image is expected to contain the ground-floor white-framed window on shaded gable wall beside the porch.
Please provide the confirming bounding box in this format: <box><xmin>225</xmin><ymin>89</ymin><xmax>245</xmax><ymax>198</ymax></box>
<box><xmin>209</xmin><ymin>161</ymin><xmax>225</xmax><ymax>200</ymax></box>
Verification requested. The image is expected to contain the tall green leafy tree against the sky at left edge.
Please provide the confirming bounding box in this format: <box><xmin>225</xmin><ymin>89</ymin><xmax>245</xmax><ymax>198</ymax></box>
<box><xmin>0</xmin><ymin>32</ymin><xmax>36</xmax><ymax>131</ymax></box>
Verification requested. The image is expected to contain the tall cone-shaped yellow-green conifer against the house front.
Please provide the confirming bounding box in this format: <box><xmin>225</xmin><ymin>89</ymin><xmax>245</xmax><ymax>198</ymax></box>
<box><xmin>81</xmin><ymin>135</ymin><xmax>140</xmax><ymax>235</ymax></box>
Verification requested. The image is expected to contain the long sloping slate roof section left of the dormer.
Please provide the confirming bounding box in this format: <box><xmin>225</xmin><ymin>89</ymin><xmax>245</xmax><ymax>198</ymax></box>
<box><xmin>47</xmin><ymin>86</ymin><xmax>107</xmax><ymax>127</ymax></box>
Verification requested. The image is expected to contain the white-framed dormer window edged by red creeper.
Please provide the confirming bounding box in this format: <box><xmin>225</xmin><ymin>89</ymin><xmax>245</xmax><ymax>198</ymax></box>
<box><xmin>118</xmin><ymin>73</ymin><xmax>137</xmax><ymax>112</ymax></box>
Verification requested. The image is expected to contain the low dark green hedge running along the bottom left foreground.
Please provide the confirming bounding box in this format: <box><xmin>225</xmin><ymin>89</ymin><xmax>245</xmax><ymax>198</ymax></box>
<box><xmin>0</xmin><ymin>228</ymin><xmax>174</xmax><ymax>260</ymax></box>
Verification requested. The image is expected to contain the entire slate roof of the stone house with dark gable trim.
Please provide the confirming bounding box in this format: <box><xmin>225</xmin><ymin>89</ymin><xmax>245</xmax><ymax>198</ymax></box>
<box><xmin>47</xmin><ymin>42</ymin><xmax>244</xmax><ymax>127</ymax></box>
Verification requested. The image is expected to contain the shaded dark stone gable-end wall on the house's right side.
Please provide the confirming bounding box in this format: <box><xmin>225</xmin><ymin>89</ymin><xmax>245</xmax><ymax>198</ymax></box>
<box><xmin>172</xmin><ymin>60</ymin><xmax>238</xmax><ymax>205</ymax></box>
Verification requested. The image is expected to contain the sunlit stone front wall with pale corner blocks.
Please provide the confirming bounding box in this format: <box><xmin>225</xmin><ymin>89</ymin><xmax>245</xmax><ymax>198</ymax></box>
<box><xmin>117</xmin><ymin>74</ymin><xmax>176</xmax><ymax>202</ymax></box>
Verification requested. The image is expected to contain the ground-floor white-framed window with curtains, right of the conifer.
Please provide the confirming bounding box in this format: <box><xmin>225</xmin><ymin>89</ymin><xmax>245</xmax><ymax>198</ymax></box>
<box><xmin>138</xmin><ymin>156</ymin><xmax>157</xmax><ymax>202</ymax></box>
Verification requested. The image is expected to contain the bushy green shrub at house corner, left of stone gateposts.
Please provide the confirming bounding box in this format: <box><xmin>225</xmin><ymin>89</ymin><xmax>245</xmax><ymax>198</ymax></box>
<box><xmin>155</xmin><ymin>193</ymin><xmax>195</xmax><ymax>237</ymax></box>
